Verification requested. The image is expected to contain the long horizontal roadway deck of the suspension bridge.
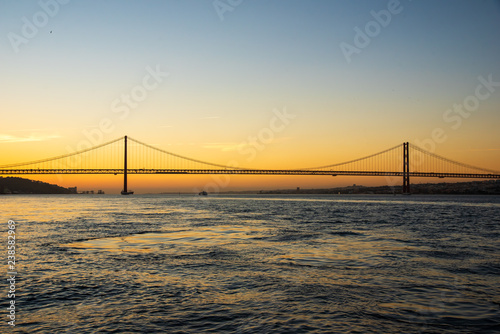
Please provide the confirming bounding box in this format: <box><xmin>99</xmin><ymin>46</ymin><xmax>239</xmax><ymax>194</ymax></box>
<box><xmin>0</xmin><ymin>168</ymin><xmax>500</xmax><ymax>179</ymax></box>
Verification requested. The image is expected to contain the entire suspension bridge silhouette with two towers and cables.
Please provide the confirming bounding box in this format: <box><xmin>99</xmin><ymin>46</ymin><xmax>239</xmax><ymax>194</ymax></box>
<box><xmin>0</xmin><ymin>136</ymin><xmax>500</xmax><ymax>193</ymax></box>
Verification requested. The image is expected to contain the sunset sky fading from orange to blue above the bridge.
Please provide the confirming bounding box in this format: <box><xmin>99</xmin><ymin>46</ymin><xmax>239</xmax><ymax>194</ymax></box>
<box><xmin>0</xmin><ymin>0</ymin><xmax>500</xmax><ymax>192</ymax></box>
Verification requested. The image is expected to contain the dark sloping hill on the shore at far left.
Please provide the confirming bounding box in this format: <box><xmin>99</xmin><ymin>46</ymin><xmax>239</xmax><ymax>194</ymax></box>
<box><xmin>0</xmin><ymin>177</ymin><xmax>76</xmax><ymax>194</ymax></box>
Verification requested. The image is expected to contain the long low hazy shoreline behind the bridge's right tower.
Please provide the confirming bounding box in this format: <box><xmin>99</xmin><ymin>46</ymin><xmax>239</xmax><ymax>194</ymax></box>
<box><xmin>254</xmin><ymin>180</ymin><xmax>500</xmax><ymax>195</ymax></box>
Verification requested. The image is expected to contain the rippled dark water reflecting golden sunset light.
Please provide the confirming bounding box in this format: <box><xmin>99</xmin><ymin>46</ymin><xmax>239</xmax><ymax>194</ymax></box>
<box><xmin>0</xmin><ymin>195</ymin><xmax>500</xmax><ymax>333</ymax></box>
